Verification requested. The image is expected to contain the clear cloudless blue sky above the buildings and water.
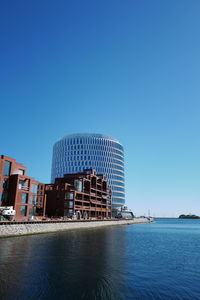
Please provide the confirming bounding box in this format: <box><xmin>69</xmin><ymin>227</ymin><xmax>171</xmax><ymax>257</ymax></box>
<box><xmin>0</xmin><ymin>0</ymin><xmax>200</xmax><ymax>216</ymax></box>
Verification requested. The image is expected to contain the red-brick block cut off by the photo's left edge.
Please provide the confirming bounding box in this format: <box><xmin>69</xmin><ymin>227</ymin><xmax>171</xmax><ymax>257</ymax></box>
<box><xmin>0</xmin><ymin>155</ymin><xmax>45</xmax><ymax>219</ymax></box>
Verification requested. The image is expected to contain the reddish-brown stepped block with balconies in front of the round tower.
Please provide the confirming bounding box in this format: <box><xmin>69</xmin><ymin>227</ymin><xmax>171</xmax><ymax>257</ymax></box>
<box><xmin>45</xmin><ymin>169</ymin><xmax>111</xmax><ymax>219</ymax></box>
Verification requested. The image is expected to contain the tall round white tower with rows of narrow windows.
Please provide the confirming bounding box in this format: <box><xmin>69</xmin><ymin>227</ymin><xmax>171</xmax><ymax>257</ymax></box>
<box><xmin>51</xmin><ymin>133</ymin><xmax>125</xmax><ymax>208</ymax></box>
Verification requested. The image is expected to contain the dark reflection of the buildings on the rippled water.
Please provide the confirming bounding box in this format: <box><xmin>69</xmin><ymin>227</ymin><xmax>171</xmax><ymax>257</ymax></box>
<box><xmin>0</xmin><ymin>227</ymin><xmax>125</xmax><ymax>299</ymax></box>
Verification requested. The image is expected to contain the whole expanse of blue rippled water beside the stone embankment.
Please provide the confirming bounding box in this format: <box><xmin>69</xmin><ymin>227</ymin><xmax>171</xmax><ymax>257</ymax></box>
<box><xmin>0</xmin><ymin>219</ymin><xmax>200</xmax><ymax>300</ymax></box>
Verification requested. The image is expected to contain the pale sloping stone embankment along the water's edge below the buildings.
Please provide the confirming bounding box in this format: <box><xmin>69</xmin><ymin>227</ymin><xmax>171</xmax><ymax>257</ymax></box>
<box><xmin>0</xmin><ymin>218</ymin><xmax>150</xmax><ymax>237</ymax></box>
